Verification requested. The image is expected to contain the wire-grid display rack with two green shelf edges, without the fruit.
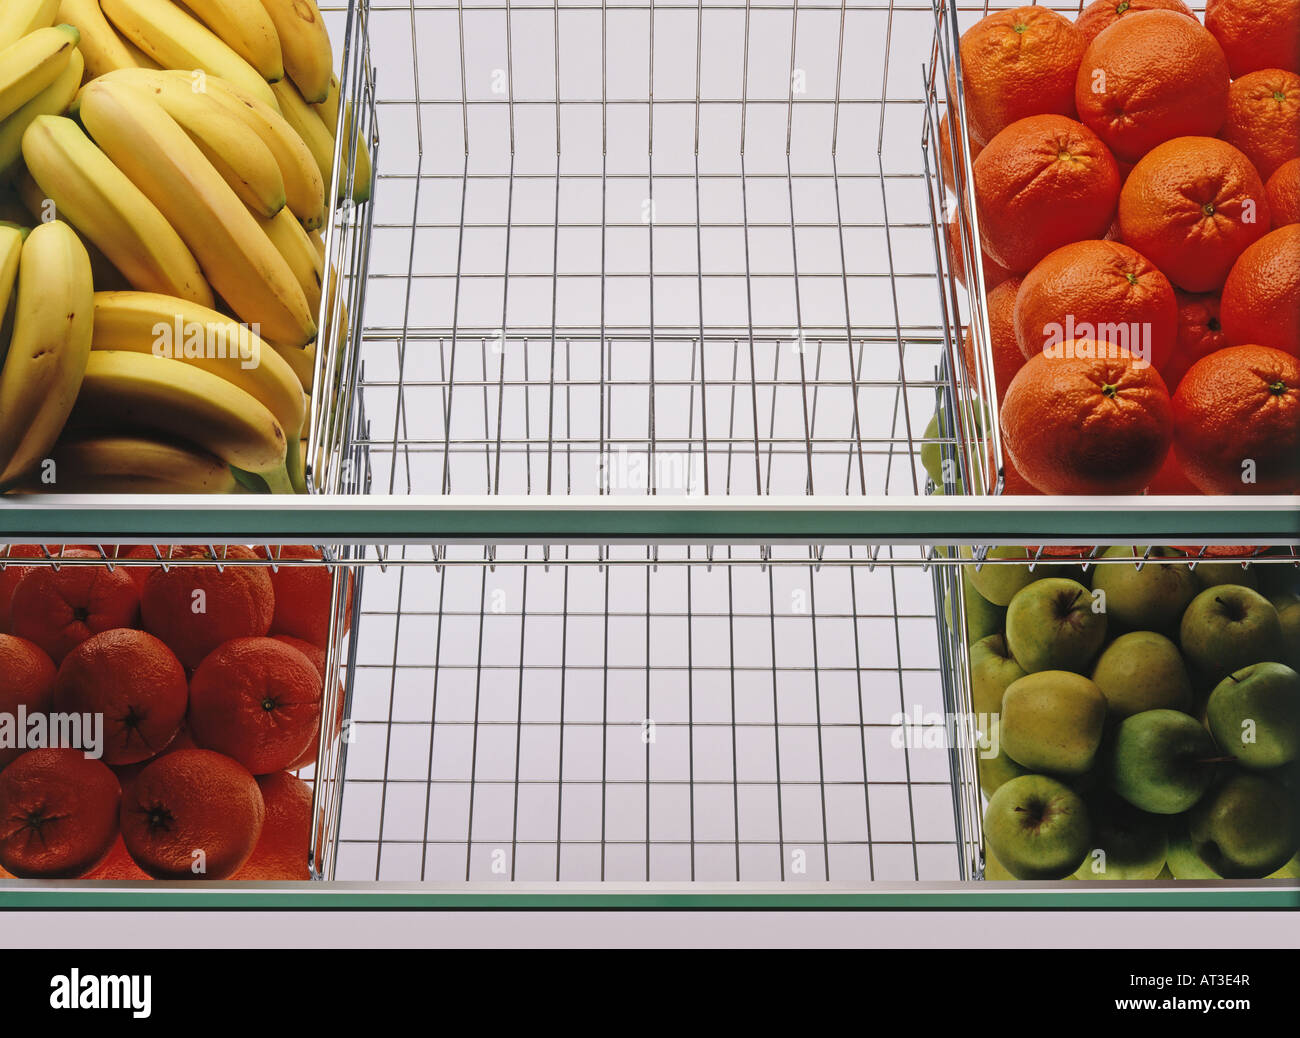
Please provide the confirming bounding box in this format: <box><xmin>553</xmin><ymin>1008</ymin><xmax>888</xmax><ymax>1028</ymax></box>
<box><xmin>0</xmin><ymin>0</ymin><xmax>1300</xmax><ymax>908</ymax></box>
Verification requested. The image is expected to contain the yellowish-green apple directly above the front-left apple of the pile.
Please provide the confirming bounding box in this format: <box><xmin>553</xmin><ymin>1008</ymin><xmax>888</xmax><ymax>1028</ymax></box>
<box><xmin>1001</xmin><ymin>670</ymin><xmax>1106</xmax><ymax>775</ymax></box>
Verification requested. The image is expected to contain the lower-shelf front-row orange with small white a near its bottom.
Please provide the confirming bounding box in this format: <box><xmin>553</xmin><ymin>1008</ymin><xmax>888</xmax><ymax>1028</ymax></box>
<box><xmin>122</xmin><ymin>749</ymin><xmax>267</xmax><ymax>879</ymax></box>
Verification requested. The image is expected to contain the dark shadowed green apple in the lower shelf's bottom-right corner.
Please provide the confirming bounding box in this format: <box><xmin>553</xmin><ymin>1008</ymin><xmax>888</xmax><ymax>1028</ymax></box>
<box><xmin>1187</xmin><ymin>771</ymin><xmax>1300</xmax><ymax>879</ymax></box>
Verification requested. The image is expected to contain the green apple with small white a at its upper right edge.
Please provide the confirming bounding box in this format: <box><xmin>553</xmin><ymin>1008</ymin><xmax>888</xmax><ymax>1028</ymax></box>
<box><xmin>1006</xmin><ymin>576</ymin><xmax>1106</xmax><ymax>674</ymax></box>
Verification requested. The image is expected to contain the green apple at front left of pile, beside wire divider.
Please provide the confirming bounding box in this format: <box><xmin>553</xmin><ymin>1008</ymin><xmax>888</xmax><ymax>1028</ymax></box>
<box><xmin>984</xmin><ymin>775</ymin><xmax>1092</xmax><ymax>879</ymax></box>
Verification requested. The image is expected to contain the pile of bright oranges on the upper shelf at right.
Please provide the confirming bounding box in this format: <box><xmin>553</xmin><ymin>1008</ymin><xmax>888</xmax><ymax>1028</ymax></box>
<box><xmin>940</xmin><ymin>0</ymin><xmax>1300</xmax><ymax>494</ymax></box>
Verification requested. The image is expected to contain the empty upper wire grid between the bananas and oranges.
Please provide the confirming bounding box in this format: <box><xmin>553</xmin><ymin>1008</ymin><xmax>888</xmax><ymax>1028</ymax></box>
<box><xmin>351</xmin><ymin>0</ymin><xmax>961</xmax><ymax>496</ymax></box>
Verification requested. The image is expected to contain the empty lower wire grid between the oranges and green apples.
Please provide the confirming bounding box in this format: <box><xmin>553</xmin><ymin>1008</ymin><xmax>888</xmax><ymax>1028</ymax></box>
<box><xmin>334</xmin><ymin>546</ymin><xmax>958</xmax><ymax>882</ymax></box>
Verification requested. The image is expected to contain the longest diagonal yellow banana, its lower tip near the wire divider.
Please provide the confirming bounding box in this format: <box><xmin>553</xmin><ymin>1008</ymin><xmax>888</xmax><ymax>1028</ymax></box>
<box><xmin>81</xmin><ymin>79</ymin><xmax>316</xmax><ymax>346</ymax></box>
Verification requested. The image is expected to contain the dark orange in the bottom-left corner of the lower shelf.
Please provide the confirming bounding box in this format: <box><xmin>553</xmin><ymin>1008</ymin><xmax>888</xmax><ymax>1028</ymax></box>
<box><xmin>0</xmin><ymin>749</ymin><xmax>121</xmax><ymax>879</ymax></box>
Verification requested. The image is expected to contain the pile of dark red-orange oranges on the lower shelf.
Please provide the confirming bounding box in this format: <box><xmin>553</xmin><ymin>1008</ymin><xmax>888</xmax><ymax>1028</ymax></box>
<box><xmin>0</xmin><ymin>545</ymin><xmax>351</xmax><ymax>881</ymax></box>
